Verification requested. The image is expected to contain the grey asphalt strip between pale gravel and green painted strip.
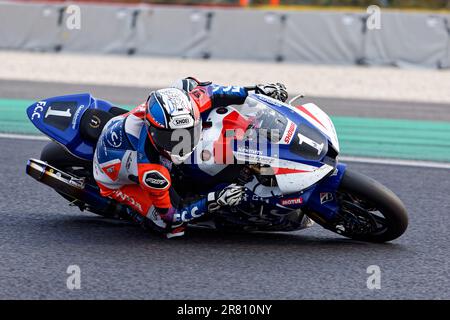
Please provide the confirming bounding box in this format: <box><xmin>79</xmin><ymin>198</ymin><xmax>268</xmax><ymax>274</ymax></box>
<box><xmin>0</xmin><ymin>80</ymin><xmax>450</xmax><ymax>121</ymax></box>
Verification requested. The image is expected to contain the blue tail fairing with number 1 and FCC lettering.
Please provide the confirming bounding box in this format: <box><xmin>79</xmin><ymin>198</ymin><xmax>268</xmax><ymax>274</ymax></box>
<box><xmin>27</xmin><ymin>93</ymin><xmax>118</xmax><ymax>160</ymax></box>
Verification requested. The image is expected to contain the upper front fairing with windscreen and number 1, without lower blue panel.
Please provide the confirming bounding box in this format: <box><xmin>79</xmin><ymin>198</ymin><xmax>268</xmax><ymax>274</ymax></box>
<box><xmin>194</xmin><ymin>94</ymin><xmax>339</xmax><ymax>194</ymax></box>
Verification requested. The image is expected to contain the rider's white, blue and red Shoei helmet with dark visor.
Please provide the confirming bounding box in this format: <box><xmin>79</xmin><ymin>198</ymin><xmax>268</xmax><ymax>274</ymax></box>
<box><xmin>145</xmin><ymin>88</ymin><xmax>202</xmax><ymax>163</ymax></box>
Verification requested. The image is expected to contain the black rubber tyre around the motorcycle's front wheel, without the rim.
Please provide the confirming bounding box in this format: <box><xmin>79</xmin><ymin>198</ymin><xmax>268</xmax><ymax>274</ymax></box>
<box><xmin>337</xmin><ymin>170</ymin><xmax>408</xmax><ymax>242</ymax></box>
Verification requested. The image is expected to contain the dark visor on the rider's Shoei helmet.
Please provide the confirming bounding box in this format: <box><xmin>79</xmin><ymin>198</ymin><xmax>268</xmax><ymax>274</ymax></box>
<box><xmin>149</xmin><ymin>122</ymin><xmax>202</xmax><ymax>156</ymax></box>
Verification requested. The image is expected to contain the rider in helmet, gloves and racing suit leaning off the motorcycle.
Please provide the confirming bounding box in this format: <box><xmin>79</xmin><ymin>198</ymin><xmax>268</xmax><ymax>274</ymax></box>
<box><xmin>94</xmin><ymin>77</ymin><xmax>287</xmax><ymax>238</ymax></box>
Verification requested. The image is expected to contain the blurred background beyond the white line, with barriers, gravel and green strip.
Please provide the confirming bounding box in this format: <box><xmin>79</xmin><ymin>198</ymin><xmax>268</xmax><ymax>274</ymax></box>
<box><xmin>0</xmin><ymin>0</ymin><xmax>450</xmax><ymax>162</ymax></box>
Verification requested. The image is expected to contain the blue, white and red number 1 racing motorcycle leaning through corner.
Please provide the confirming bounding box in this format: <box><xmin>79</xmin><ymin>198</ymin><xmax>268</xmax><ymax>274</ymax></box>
<box><xmin>26</xmin><ymin>93</ymin><xmax>408</xmax><ymax>242</ymax></box>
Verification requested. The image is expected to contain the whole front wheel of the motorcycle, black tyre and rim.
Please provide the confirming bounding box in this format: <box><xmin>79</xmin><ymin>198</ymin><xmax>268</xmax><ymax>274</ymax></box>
<box><xmin>310</xmin><ymin>170</ymin><xmax>408</xmax><ymax>242</ymax></box>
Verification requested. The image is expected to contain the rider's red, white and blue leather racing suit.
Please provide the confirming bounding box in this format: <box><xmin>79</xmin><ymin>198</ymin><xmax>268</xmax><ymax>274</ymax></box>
<box><xmin>94</xmin><ymin>79</ymin><xmax>248</xmax><ymax>230</ymax></box>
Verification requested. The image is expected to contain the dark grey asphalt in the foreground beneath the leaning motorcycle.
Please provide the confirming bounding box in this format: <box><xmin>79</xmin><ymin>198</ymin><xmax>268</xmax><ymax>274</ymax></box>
<box><xmin>0</xmin><ymin>139</ymin><xmax>450</xmax><ymax>299</ymax></box>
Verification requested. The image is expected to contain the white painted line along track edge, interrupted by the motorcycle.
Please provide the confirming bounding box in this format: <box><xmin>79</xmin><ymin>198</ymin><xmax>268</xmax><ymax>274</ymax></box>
<box><xmin>0</xmin><ymin>133</ymin><xmax>450</xmax><ymax>169</ymax></box>
